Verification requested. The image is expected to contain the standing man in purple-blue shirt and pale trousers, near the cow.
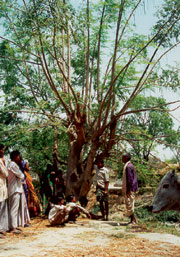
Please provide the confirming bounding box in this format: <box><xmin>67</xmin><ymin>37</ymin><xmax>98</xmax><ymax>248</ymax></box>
<box><xmin>122</xmin><ymin>153</ymin><xmax>138</xmax><ymax>224</ymax></box>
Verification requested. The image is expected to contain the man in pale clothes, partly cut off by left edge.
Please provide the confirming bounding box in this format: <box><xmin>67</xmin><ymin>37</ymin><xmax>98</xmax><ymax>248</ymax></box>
<box><xmin>0</xmin><ymin>144</ymin><xmax>9</xmax><ymax>238</ymax></box>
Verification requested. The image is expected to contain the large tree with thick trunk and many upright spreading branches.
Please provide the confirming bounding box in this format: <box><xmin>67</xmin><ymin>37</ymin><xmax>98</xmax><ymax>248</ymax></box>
<box><xmin>0</xmin><ymin>0</ymin><xmax>180</xmax><ymax>199</ymax></box>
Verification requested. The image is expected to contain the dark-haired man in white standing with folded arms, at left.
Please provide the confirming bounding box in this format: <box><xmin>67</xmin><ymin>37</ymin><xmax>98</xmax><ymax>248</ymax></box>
<box><xmin>8</xmin><ymin>150</ymin><xmax>24</xmax><ymax>234</ymax></box>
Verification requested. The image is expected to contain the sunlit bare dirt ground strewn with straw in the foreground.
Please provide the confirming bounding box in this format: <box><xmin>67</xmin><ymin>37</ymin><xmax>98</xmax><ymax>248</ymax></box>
<box><xmin>0</xmin><ymin>218</ymin><xmax>180</xmax><ymax>257</ymax></box>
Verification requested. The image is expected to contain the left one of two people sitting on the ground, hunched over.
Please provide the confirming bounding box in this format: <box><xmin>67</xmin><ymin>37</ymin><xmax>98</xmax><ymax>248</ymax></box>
<box><xmin>48</xmin><ymin>197</ymin><xmax>68</xmax><ymax>226</ymax></box>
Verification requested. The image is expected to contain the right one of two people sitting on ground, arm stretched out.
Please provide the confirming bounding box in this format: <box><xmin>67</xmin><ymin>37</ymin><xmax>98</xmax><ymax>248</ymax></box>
<box><xmin>66</xmin><ymin>195</ymin><xmax>91</xmax><ymax>222</ymax></box>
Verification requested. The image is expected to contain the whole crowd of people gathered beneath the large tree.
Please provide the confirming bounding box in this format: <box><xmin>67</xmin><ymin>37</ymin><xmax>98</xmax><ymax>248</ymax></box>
<box><xmin>0</xmin><ymin>141</ymin><xmax>138</xmax><ymax>238</ymax></box>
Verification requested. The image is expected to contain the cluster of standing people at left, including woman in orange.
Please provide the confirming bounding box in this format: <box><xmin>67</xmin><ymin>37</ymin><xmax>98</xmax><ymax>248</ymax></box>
<box><xmin>0</xmin><ymin>144</ymin><xmax>40</xmax><ymax>238</ymax></box>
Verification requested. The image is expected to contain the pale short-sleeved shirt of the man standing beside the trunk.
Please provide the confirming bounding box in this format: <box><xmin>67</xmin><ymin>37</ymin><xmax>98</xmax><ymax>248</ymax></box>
<box><xmin>95</xmin><ymin>166</ymin><xmax>109</xmax><ymax>189</ymax></box>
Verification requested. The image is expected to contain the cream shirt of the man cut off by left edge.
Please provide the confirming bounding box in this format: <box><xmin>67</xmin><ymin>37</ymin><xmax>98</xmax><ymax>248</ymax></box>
<box><xmin>0</xmin><ymin>158</ymin><xmax>8</xmax><ymax>202</ymax></box>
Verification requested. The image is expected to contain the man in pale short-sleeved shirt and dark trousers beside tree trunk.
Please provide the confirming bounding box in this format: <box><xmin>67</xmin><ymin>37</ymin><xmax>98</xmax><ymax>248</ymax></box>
<box><xmin>96</xmin><ymin>160</ymin><xmax>109</xmax><ymax>220</ymax></box>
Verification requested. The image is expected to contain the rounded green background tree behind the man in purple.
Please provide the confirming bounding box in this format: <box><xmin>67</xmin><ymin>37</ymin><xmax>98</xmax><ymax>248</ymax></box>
<box><xmin>121</xmin><ymin>95</ymin><xmax>174</xmax><ymax>161</ymax></box>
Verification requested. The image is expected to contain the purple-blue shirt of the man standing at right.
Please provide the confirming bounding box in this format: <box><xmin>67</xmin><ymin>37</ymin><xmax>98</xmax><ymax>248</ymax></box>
<box><xmin>126</xmin><ymin>162</ymin><xmax>138</xmax><ymax>192</ymax></box>
